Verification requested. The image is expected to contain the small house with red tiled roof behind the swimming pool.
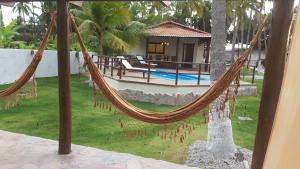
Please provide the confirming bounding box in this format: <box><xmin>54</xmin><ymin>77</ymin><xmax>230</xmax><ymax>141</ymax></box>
<box><xmin>128</xmin><ymin>21</ymin><xmax>211</xmax><ymax>67</ymax></box>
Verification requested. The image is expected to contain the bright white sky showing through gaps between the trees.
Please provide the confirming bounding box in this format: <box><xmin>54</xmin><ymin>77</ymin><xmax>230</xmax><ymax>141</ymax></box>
<box><xmin>2</xmin><ymin>0</ymin><xmax>299</xmax><ymax>25</ymax></box>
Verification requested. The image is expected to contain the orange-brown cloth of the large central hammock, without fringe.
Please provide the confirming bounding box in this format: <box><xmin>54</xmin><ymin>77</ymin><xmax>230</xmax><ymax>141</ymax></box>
<box><xmin>70</xmin><ymin>14</ymin><xmax>267</xmax><ymax>124</ymax></box>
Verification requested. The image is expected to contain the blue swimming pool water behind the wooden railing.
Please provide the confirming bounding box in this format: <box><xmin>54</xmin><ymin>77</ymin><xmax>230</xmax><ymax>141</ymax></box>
<box><xmin>151</xmin><ymin>70</ymin><xmax>210</xmax><ymax>81</ymax></box>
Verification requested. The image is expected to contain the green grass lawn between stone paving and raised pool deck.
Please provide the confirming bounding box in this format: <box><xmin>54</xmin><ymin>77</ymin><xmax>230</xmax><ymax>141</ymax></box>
<box><xmin>0</xmin><ymin>76</ymin><xmax>262</xmax><ymax>163</ymax></box>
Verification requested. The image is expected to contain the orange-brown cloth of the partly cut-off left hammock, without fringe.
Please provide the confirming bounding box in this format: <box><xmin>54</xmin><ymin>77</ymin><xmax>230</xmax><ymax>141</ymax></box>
<box><xmin>0</xmin><ymin>14</ymin><xmax>56</xmax><ymax>97</ymax></box>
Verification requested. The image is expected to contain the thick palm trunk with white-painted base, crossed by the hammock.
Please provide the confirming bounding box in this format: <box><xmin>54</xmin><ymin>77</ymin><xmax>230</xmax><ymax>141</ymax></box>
<box><xmin>206</xmin><ymin>0</ymin><xmax>236</xmax><ymax>159</ymax></box>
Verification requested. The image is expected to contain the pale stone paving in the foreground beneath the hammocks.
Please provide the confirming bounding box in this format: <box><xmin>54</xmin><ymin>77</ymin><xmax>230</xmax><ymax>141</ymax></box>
<box><xmin>0</xmin><ymin>130</ymin><xmax>197</xmax><ymax>169</ymax></box>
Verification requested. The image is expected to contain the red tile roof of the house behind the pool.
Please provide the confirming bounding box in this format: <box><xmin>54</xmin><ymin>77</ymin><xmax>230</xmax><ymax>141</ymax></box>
<box><xmin>145</xmin><ymin>21</ymin><xmax>211</xmax><ymax>38</ymax></box>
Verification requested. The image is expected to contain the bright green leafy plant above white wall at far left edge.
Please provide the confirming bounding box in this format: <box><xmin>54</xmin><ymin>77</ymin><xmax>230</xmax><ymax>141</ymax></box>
<box><xmin>0</xmin><ymin>20</ymin><xmax>19</xmax><ymax>48</ymax></box>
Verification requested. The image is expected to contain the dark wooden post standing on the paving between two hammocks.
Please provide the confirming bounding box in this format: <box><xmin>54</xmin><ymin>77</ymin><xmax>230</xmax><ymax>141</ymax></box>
<box><xmin>56</xmin><ymin>0</ymin><xmax>72</xmax><ymax>154</ymax></box>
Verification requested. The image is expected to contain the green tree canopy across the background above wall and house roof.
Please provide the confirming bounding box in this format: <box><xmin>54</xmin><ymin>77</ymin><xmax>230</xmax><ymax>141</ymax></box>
<box><xmin>0</xmin><ymin>0</ymin><xmax>276</xmax><ymax>55</ymax></box>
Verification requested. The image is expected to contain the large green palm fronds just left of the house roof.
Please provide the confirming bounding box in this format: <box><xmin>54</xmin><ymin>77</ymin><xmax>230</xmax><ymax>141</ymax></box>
<box><xmin>72</xmin><ymin>2</ymin><xmax>144</xmax><ymax>55</ymax></box>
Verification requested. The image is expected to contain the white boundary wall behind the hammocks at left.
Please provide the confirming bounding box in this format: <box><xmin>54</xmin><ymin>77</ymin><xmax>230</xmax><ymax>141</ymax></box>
<box><xmin>0</xmin><ymin>48</ymin><xmax>84</xmax><ymax>84</ymax></box>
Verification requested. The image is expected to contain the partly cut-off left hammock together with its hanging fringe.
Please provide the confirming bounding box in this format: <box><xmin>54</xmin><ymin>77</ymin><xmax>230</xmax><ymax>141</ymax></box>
<box><xmin>0</xmin><ymin>14</ymin><xmax>56</xmax><ymax>109</ymax></box>
